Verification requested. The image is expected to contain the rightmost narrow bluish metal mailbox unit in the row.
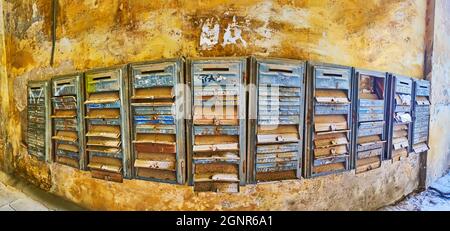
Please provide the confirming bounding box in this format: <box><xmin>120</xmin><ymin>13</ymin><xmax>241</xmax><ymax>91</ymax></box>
<box><xmin>411</xmin><ymin>80</ymin><xmax>430</xmax><ymax>153</ymax></box>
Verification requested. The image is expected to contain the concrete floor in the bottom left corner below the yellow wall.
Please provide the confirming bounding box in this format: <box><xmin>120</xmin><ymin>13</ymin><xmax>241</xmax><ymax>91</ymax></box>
<box><xmin>0</xmin><ymin>172</ymin><xmax>84</xmax><ymax>211</ymax></box>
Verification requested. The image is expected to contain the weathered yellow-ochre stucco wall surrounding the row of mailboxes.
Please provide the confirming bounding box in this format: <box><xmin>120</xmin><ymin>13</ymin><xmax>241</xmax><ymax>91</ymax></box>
<box><xmin>0</xmin><ymin>0</ymin><xmax>426</xmax><ymax>210</ymax></box>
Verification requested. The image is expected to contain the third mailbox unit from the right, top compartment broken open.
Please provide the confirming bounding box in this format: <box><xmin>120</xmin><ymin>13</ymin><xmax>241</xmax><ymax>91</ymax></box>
<box><xmin>353</xmin><ymin>69</ymin><xmax>387</xmax><ymax>173</ymax></box>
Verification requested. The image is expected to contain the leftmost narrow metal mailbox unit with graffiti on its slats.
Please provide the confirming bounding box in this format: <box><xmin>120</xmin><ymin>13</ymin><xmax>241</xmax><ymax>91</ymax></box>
<box><xmin>27</xmin><ymin>81</ymin><xmax>52</xmax><ymax>162</ymax></box>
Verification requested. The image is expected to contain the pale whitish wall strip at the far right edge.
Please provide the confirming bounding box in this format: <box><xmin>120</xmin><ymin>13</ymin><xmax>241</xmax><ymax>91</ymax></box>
<box><xmin>427</xmin><ymin>0</ymin><xmax>450</xmax><ymax>184</ymax></box>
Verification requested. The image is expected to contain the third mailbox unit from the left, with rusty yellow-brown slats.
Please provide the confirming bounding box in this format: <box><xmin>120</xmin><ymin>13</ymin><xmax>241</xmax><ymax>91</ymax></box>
<box><xmin>84</xmin><ymin>66</ymin><xmax>131</xmax><ymax>182</ymax></box>
